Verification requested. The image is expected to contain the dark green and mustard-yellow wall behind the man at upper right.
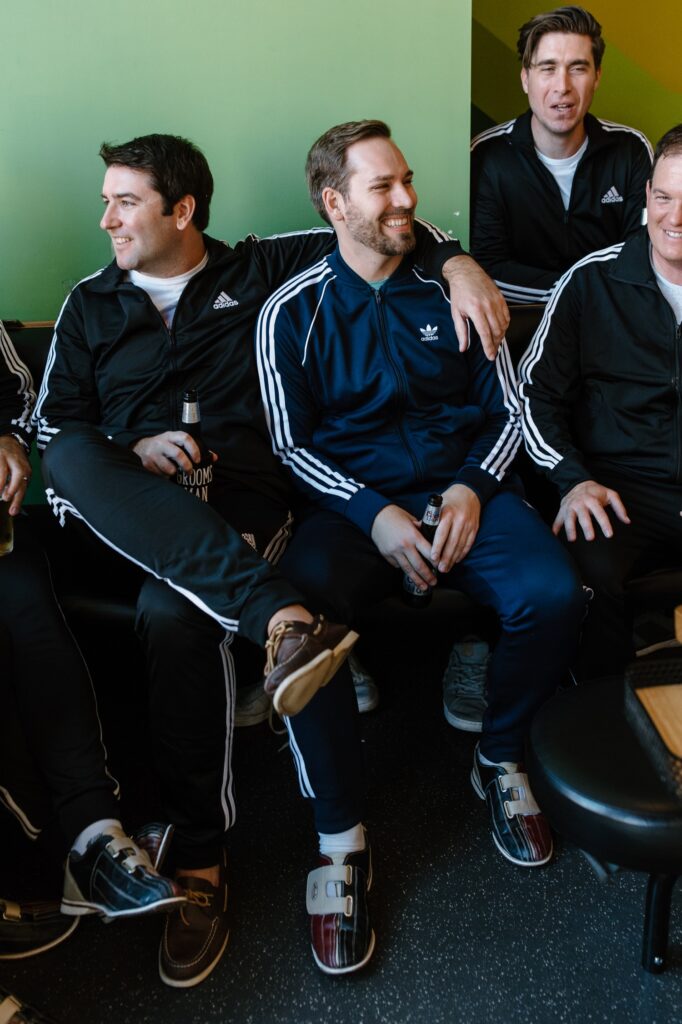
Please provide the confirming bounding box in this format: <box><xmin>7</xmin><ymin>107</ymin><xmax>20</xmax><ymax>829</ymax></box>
<box><xmin>472</xmin><ymin>0</ymin><xmax>682</xmax><ymax>144</ymax></box>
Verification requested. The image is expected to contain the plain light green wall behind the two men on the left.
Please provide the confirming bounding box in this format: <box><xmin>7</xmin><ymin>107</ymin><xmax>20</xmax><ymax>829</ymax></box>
<box><xmin>0</xmin><ymin>0</ymin><xmax>471</xmax><ymax>319</ymax></box>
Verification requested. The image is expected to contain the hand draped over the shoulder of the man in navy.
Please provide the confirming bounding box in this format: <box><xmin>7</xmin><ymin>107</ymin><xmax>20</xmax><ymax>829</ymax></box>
<box><xmin>442</xmin><ymin>256</ymin><xmax>509</xmax><ymax>359</ymax></box>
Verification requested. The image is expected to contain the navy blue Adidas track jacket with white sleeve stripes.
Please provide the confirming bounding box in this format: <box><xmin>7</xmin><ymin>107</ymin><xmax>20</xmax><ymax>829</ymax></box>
<box><xmin>256</xmin><ymin>249</ymin><xmax>520</xmax><ymax>535</ymax></box>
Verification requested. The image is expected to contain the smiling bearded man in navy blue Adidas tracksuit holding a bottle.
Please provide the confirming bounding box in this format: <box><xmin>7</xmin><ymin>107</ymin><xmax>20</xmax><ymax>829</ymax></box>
<box><xmin>257</xmin><ymin>121</ymin><xmax>584</xmax><ymax>897</ymax></box>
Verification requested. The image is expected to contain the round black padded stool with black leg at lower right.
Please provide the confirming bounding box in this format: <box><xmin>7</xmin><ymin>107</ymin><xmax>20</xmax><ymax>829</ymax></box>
<box><xmin>527</xmin><ymin>667</ymin><xmax>682</xmax><ymax>973</ymax></box>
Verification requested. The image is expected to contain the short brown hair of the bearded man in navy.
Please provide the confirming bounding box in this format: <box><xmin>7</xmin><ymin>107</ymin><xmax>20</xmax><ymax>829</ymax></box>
<box><xmin>305</xmin><ymin>121</ymin><xmax>391</xmax><ymax>223</ymax></box>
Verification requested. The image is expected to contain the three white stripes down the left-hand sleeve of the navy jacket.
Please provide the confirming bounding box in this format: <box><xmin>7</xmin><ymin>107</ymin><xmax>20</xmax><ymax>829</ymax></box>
<box><xmin>256</xmin><ymin>260</ymin><xmax>363</xmax><ymax>501</ymax></box>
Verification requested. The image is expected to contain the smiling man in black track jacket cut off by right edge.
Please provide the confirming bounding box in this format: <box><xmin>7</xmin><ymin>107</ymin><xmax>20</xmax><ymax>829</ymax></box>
<box><xmin>520</xmin><ymin>125</ymin><xmax>682</xmax><ymax>678</ymax></box>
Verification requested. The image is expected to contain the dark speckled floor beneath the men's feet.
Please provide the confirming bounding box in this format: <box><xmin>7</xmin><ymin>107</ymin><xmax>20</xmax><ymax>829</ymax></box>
<box><xmin>0</xmin><ymin>618</ymin><xmax>682</xmax><ymax>1024</ymax></box>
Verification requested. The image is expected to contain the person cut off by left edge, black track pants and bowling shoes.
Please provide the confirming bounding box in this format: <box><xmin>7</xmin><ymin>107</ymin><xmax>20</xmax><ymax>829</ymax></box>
<box><xmin>0</xmin><ymin>323</ymin><xmax>183</xmax><ymax>966</ymax></box>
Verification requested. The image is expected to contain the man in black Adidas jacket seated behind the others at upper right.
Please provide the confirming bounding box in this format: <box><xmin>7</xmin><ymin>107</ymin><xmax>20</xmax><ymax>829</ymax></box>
<box><xmin>471</xmin><ymin>7</ymin><xmax>651</xmax><ymax>302</ymax></box>
